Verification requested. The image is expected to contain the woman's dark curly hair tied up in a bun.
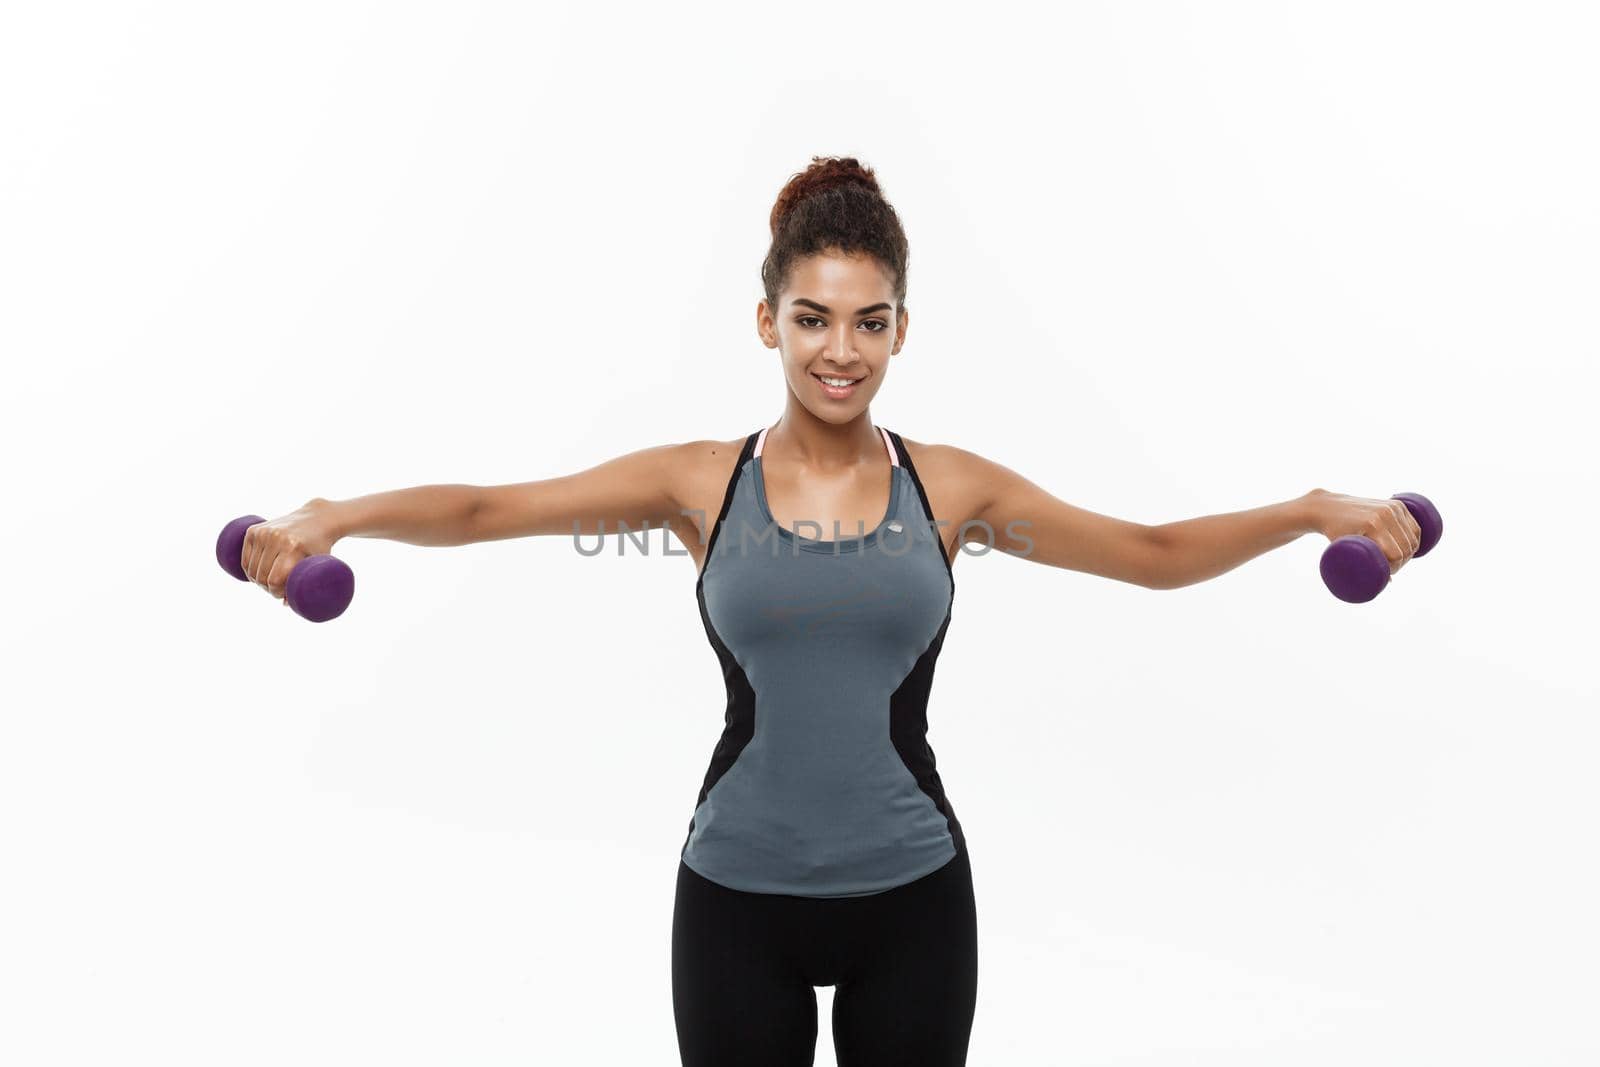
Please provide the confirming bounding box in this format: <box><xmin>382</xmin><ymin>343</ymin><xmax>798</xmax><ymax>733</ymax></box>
<box><xmin>762</xmin><ymin>155</ymin><xmax>910</xmax><ymax>314</ymax></box>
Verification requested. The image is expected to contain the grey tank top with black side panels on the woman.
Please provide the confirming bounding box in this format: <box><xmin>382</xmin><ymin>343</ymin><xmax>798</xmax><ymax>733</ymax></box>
<box><xmin>682</xmin><ymin>427</ymin><xmax>966</xmax><ymax>897</ymax></box>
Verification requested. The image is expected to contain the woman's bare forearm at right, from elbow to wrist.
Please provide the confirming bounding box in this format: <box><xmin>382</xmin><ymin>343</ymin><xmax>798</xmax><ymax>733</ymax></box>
<box><xmin>1150</xmin><ymin>494</ymin><xmax>1317</xmax><ymax>589</ymax></box>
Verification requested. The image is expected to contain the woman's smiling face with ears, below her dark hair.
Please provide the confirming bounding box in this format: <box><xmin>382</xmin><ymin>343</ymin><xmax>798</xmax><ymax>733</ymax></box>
<box><xmin>757</xmin><ymin>253</ymin><xmax>907</xmax><ymax>424</ymax></box>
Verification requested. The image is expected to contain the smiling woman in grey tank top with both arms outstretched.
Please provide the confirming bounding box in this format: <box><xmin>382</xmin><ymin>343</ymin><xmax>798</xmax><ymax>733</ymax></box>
<box><xmin>243</xmin><ymin>157</ymin><xmax>1419</xmax><ymax>1067</ymax></box>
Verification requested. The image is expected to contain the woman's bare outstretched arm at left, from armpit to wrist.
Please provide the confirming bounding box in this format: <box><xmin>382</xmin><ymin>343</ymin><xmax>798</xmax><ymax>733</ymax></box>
<box><xmin>307</xmin><ymin>445</ymin><xmax>686</xmax><ymax>545</ymax></box>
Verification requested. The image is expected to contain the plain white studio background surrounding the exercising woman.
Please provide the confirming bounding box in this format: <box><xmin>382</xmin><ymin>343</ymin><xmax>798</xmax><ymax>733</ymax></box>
<box><xmin>0</xmin><ymin>2</ymin><xmax>1600</xmax><ymax>1067</ymax></box>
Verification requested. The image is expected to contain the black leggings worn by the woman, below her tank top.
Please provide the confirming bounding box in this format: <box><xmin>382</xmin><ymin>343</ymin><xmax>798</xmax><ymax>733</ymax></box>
<box><xmin>672</xmin><ymin>848</ymin><xmax>978</xmax><ymax>1067</ymax></box>
